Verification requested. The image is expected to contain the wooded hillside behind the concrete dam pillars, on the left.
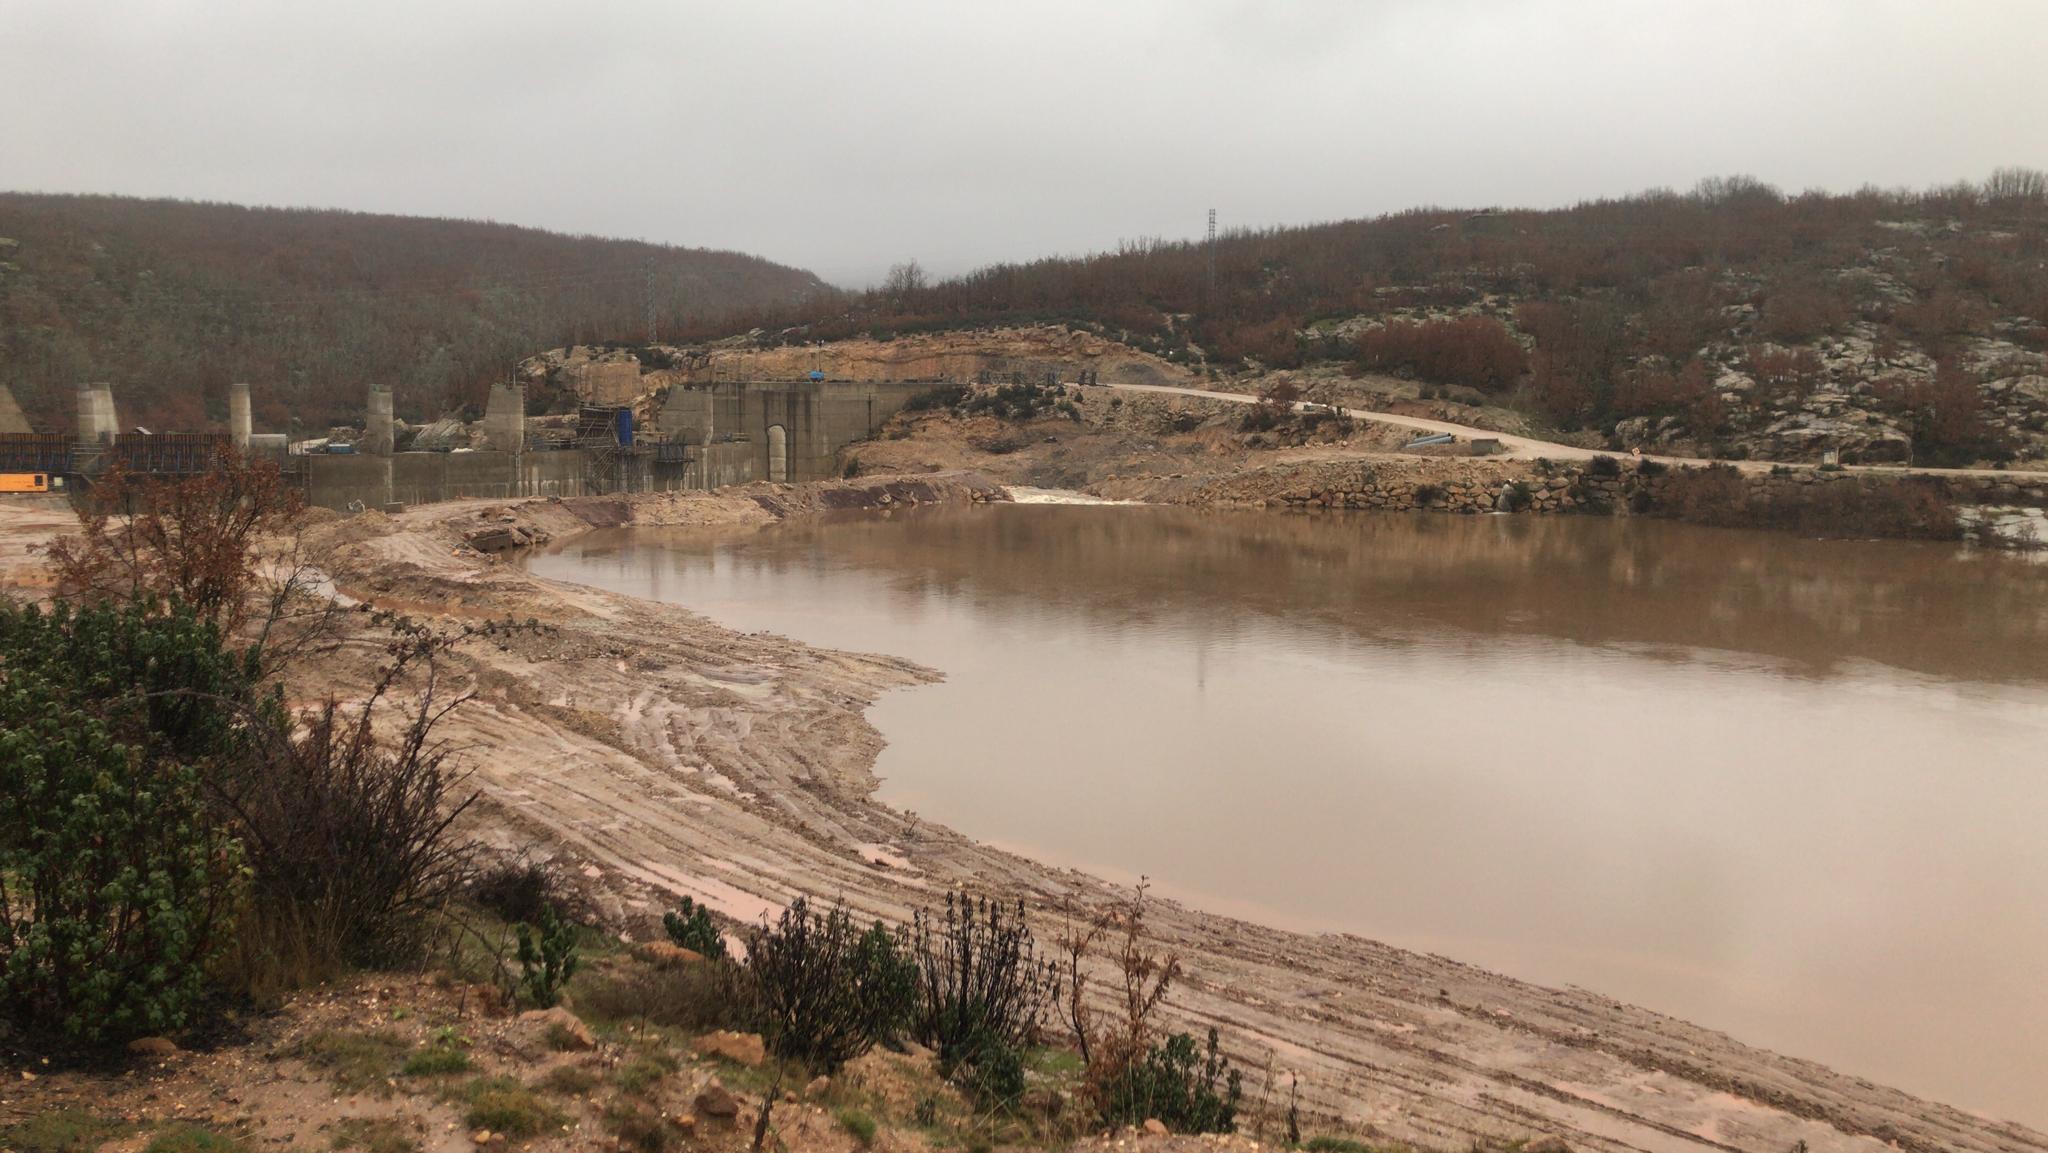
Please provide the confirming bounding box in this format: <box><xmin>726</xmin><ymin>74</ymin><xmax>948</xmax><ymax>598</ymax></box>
<box><xmin>0</xmin><ymin>193</ymin><xmax>823</xmax><ymax>430</ymax></box>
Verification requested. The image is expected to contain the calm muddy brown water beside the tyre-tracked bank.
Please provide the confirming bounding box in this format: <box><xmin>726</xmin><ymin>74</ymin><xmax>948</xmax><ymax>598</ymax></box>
<box><xmin>530</xmin><ymin>506</ymin><xmax>2048</xmax><ymax>1124</ymax></box>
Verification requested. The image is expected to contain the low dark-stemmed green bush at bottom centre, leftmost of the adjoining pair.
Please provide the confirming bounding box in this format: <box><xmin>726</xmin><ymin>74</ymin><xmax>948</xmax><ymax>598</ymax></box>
<box><xmin>748</xmin><ymin>897</ymin><xmax>915</xmax><ymax>1073</ymax></box>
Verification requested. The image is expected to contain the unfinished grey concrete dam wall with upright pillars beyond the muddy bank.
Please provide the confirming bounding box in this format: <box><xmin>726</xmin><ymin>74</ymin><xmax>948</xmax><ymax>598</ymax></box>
<box><xmin>293</xmin><ymin>381</ymin><xmax>932</xmax><ymax>510</ymax></box>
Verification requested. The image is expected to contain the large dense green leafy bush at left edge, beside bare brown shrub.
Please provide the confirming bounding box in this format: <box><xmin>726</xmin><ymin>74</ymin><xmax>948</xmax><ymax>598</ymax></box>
<box><xmin>0</xmin><ymin>604</ymin><xmax>244</xmax><ymax>1042</ymax></box>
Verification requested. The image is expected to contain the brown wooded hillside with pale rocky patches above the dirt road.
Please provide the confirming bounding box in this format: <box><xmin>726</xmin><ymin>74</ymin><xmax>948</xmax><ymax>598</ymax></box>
<box><xmin>702</xmin><ymin>170</ymin><xmax>2048</xmax><ymax>463</ymax></box>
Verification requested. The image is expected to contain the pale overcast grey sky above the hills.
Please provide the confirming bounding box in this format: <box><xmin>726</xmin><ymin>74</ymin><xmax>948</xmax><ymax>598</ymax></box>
<box><xmin>0</xmin><ymin>0</ymin><xmax>2048</xmax><ymax>285</ymax></box>
